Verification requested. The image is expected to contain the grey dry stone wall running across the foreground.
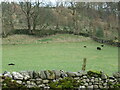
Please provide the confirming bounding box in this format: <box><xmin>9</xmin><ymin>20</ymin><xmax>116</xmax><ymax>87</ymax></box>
<box><xmin>1</xmin><ymin>70</ymin><xmax>120</xmax><ymax>89</ymax></box>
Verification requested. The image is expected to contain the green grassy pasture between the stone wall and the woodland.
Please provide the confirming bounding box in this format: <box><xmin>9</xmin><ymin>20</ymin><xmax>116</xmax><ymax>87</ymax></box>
<box><xmin>2</xmin><ymin>34</ymin><xmax>118</xmax><ymax>74</ymax></box>
